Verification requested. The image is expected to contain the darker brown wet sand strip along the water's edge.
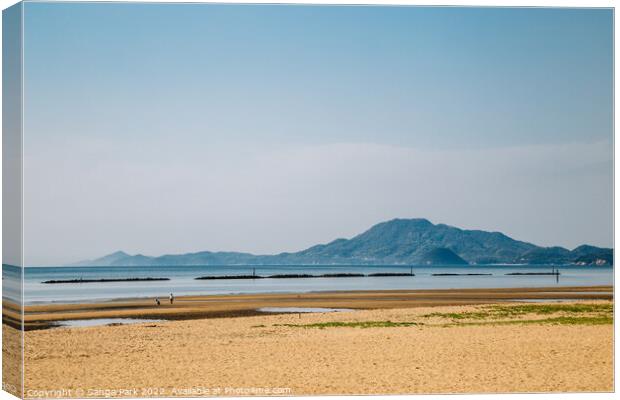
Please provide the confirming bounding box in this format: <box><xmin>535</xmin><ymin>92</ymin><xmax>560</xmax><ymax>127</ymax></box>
<box><xmin>3</xmin><ymin>286</ymin><xmax>613</xmax><ymax>330</ymax></box>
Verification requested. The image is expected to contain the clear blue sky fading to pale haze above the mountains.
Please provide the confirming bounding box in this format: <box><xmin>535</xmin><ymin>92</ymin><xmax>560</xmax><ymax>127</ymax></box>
<box><xmin>18</xmin><ymin>2</ymin><xmax>613</xmax><ymax>265</ymax></box>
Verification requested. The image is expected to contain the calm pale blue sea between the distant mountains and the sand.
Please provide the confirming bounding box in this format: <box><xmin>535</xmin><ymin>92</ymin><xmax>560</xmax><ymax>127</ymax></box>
<box><xmin>2</xmin><ymin>265</ymin><xmax>613</xmax><ymax>304</ymax></box>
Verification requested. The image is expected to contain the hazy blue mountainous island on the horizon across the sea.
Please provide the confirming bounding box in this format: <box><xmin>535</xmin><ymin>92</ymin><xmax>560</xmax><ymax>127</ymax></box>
<box><xmin>73</xmin><ymin>218</ymin><xmax>613</xmax><ymax>266</ymax></box>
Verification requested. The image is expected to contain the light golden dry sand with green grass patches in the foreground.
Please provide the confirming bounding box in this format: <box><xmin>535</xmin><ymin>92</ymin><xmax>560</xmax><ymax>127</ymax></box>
<box><xmin>5</xmin><ymin>288</ymin><xmax>614</xmax><ymax>397</ymax></box>
